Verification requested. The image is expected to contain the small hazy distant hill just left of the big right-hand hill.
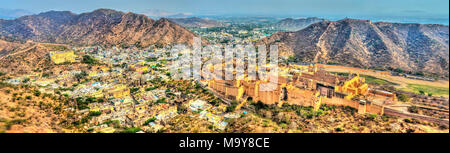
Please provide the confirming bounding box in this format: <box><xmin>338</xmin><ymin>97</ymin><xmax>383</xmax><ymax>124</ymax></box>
<box><xmin>273</xmin><ymin>17</ymin><xmax>325</xmax><ymax>31</ymax></box>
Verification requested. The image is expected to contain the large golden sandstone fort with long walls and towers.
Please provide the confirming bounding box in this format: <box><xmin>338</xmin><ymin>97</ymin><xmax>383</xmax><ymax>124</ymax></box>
<box><xmin>204</xmin><ymin>65</ymin><xmax>397</xmax><ymax>115</ymax></box>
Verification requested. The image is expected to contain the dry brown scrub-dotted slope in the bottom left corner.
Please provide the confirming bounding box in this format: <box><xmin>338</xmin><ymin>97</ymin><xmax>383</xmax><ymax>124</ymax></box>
<box><xmin>0</xmin><ymin>82</ymin><xmax>76</xmax><ymax>133</ymax></box>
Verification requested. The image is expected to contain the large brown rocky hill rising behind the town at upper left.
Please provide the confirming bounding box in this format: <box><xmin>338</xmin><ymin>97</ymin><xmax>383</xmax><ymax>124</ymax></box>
<box><xmin>0</xmin><ymin>9</ymin><xmax>200</xmax><ymax>47</ymax></box>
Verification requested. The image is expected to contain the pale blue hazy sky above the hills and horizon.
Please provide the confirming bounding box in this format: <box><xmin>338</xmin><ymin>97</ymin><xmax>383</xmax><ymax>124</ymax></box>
<box><xmin>0</xmin><ymin>0</ymin><xmax>449</xmax><ymax>22</ymax></box>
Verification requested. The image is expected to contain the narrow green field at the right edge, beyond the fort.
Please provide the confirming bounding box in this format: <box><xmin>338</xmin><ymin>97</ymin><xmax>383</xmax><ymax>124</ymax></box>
<box><xmin>399</xmin><ymin>84</ymin><xmax>449</xmax><ymax>97</ymax></box>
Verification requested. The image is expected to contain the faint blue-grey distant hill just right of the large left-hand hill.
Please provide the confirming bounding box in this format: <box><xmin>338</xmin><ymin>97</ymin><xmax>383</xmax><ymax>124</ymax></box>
<box><xmin>169</xmin><ymin>17</ymin><xmax>228</xmax><ymax>27</ymax></box>
